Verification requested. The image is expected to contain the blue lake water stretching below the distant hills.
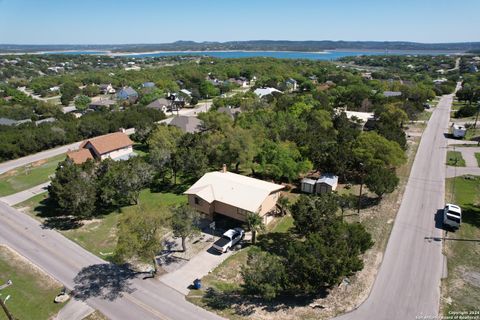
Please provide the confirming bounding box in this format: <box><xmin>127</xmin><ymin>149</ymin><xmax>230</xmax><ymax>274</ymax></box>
<box><xmin>44</xmin><ymin>50</ymin><xmax>456</xmax><ymax>60</ymax></box>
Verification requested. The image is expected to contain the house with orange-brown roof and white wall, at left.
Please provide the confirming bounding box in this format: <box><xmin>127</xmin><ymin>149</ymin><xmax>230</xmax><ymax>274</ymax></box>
<box><xmin>67</xmin><ymin>132</ymin><xmax>135</xmax><ymax>164</ymax></box>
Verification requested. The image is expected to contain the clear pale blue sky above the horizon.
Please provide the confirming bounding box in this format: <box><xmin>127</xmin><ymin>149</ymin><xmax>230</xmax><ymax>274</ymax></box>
<box><xmin>0</xmin><ymin>0</ymin><xmax>480</xmax><ymax>44</ymax></box>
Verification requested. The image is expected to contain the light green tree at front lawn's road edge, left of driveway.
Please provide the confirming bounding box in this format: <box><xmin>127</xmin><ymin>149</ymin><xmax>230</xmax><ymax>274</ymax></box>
<box><xmin>115</xmin><ymin>206</ymin><xmax>166</xmax><ymax>273</ymax></box>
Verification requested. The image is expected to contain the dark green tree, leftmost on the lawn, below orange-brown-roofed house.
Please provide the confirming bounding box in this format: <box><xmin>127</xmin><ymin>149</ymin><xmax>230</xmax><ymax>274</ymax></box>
<box><xmin>48</xmin><ymin>160</ymin><xmax>97</xmax><ymax>217</ymax></box>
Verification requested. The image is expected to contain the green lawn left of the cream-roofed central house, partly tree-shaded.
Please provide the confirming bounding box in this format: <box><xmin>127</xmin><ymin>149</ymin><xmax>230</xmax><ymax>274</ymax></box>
<box><xmin>16</xmin><ymin>189</ymin><xmax>187</xmax><ymax>259</ymax></box>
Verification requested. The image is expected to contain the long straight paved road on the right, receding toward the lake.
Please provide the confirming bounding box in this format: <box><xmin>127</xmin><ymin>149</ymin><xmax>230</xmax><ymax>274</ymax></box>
<box><xmin>339</xmin><ymin>89</ymin><xmax>458</xmax><ymax>320</ymax></box>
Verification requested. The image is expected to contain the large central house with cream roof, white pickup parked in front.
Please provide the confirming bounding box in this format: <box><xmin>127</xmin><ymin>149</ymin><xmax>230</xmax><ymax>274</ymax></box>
<box><xmin>184</xmin><ymin>167</ymin><xmax>284</xmax><ymax>222</ymax></box>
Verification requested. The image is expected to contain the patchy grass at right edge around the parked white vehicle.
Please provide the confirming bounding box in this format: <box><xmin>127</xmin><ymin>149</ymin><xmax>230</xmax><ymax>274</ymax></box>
<box><xmin>442</xmin><ymin>177</ymin><xmax>480</xmax><ymax>315</ymax></box>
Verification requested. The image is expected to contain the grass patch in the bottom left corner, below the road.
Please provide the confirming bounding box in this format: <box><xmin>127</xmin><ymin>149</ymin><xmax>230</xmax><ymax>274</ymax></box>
<box><xmin>0</xmin><ymin>246</ymin><xmax>63</xmax><ymax>320</ymax></box>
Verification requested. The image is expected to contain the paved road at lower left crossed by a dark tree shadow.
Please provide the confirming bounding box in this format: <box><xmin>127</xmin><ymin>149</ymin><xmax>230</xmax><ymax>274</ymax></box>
<box><xmin>0</xmin><ymin>202</ymin><xmax>225</xmax><ymax>320</ymax></box>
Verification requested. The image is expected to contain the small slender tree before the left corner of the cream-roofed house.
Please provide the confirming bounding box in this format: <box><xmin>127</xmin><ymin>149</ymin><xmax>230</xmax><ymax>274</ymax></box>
<box><xmin>170</xmin><ymin>204</ymin><xmax>200</xmax><ymax>251</ymax></box>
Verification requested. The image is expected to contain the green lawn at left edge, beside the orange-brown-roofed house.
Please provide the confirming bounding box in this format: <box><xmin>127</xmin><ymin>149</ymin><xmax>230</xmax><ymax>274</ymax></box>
<box><xmin>0</xmin><ymin>154</ymin><xmax>65</xmax><ymax>196</ymax></box>
